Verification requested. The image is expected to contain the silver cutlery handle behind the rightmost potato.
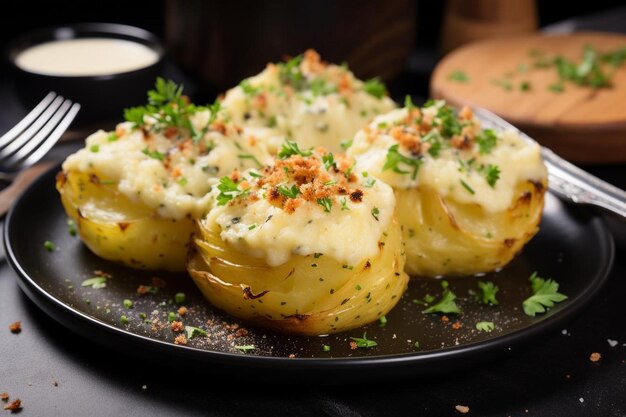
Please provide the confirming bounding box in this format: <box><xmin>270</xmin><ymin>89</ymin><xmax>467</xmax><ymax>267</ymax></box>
<box><xmin>473</xmin><ymin>108</ymin><xmax>626</xmax><ymax>219</ymax></box>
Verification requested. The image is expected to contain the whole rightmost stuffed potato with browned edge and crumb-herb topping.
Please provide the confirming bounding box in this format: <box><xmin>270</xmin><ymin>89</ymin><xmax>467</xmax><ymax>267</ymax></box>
<box><xmin>347</xmin><ymin>101</ymin><xmax>547</xmax><ymax>276</ymax></box>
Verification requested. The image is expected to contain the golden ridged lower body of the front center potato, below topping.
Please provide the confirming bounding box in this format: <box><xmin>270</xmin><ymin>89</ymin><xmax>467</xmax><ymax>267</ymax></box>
<box><xmin>187</xmin><ymin>214</ymin><xmax>408</xmax><ymax>335</ymax></box>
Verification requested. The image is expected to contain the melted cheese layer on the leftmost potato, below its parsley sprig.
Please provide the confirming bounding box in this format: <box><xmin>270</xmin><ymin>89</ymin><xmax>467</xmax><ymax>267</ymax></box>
<box><xmin>63</xmin><ymin>111</ymin><xmax>271</xmax><ymax>219</ymax></box>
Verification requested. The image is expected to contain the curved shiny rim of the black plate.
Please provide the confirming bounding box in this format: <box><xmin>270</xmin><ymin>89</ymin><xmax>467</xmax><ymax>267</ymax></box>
<box><xmin>3</xmin><ymin>164</ymin><xmax>615</xmax><ymax>374</ymax></box>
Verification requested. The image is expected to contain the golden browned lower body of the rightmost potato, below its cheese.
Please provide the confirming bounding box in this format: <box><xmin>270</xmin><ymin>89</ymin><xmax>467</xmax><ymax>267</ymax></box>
<box><xmin>396</xmin><ymin>181</ymin><xmax>547</xmax><ymax>277</ymax></box>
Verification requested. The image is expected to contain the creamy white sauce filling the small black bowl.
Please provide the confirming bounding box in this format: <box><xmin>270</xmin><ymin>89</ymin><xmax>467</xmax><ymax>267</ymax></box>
<box><xmin>15</xmin><ymin>38</ymin><xmax>159</xmax><ymax>76</ymax></box>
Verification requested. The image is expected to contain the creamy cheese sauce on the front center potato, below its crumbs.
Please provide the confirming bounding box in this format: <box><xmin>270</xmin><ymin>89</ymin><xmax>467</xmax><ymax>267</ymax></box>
<box><xmin>203</xmin><ymin>154</ymin><xmax>395</xmax><ymax>267</ymax></box>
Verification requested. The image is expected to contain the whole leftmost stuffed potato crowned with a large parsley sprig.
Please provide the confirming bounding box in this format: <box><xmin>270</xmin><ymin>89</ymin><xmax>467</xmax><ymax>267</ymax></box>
<box><xmin>57</xmin><ymin>80</ymin><xmax>270</xmax><ymax>271</ymax></box>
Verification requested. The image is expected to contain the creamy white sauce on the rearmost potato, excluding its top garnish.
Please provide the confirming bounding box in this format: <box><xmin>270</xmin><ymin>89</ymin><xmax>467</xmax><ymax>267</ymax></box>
<box><xmin>222</xmin><ymin>61</ymin><xmax>395</xmax><ymax>152</ymax></box>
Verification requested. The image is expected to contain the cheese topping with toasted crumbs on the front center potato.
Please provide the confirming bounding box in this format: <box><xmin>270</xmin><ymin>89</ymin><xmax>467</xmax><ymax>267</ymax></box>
<box><xmin>202</xmin><ymin>150</ymin><xmax>395</xmax><ymax>268</ymax></box>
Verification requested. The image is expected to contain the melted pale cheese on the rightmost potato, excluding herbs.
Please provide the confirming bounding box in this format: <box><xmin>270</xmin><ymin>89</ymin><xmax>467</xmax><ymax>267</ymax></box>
<box><xmin>347</xmin><ymin>103</ymin><xmax>547</xmax><ymax>212</ymax></box>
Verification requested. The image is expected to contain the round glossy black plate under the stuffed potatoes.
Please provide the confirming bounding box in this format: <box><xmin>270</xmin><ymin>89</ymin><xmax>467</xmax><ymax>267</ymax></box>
<box><xmin>4</xmin><ymin>166</ymin><xmax>614</xmax><ymax>382</ymax></box>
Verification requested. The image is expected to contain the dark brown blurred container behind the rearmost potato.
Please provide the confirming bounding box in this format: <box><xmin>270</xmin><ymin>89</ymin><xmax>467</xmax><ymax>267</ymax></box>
<box><xmin>165</xmin><ymin>0</ymin><xmax>416</xmax><ymax>93</ymax></box>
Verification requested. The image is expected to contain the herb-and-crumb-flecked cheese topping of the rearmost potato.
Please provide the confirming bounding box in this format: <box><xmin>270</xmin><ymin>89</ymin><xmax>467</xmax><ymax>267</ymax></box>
<box><xmin>222</xmin><ymin>51</ymin><xmax>395</xmax><ymax>152</ymax></box>
